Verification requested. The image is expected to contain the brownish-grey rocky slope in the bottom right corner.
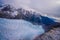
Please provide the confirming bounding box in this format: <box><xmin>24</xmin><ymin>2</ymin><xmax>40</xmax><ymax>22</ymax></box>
<box><xmin>35</xmin><ymin>27</ymin><xmax>60</xmax><ymax>40</ymax></box>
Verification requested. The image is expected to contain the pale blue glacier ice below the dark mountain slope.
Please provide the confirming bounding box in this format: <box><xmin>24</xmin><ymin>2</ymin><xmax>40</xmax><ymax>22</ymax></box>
<box><xmin>0</xmin><ymin>18</ymin><xmax>44</xmax><ymax>40</ymax></box>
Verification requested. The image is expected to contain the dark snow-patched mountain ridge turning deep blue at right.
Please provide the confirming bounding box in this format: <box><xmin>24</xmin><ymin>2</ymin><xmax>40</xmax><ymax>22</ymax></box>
<box><xmin>0</xmin><ymin>5</ymin><xmax>59</xmax><ymax>25</ymax></box>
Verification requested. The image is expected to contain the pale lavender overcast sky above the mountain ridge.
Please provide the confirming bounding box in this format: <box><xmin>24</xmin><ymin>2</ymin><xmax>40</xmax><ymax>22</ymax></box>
<box><xmin>0</xmin><ymin>0</ymin><xmax>60</xmax><ymax>18</ymax></box>
